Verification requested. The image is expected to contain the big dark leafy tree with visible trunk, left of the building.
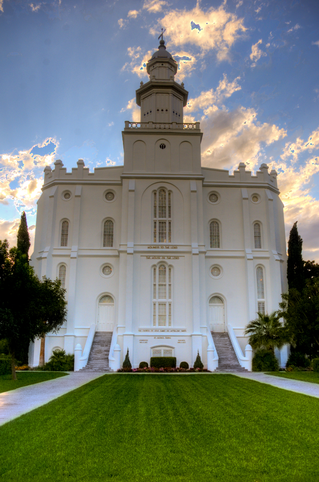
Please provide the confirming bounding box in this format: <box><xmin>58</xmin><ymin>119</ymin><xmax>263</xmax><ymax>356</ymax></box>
<box><xmin>0</xmin><ymin>240</ymin><xmax>66</xmax><ymax>380</ymax></box>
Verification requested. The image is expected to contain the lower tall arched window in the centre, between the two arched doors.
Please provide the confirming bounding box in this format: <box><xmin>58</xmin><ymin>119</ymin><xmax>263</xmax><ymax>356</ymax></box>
<box><xmin>153</xmin><ymin>264</ymin><xmax>172</xmax><ymax>326</ymax></box>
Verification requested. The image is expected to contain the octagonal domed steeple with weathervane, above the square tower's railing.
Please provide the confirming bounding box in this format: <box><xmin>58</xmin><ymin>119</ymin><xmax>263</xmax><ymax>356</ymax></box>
<box><xmin>136</xmin><ymin>35</ymin><xmax>188</xmax><ymax>123</ymax></box>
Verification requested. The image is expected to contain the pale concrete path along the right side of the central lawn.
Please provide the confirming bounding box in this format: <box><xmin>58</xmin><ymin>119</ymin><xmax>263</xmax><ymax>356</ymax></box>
<box><xmin>233</xmin><ymin>372</ymin><xmax>319</xmax><ymax>398</ymax></box>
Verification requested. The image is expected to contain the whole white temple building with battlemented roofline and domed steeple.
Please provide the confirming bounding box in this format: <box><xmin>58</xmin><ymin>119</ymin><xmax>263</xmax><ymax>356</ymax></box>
<box><xmin>30</xmin><ymin>40</ymin><xmax>287</xmax><ymax>370</ymax></box>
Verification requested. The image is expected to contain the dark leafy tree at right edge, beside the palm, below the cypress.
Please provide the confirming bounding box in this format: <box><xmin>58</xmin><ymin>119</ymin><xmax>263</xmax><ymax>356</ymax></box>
<box><xmin>280</xmin><ymin>278</ymin><xmax>319</xmax><ymax>358</ymax></box>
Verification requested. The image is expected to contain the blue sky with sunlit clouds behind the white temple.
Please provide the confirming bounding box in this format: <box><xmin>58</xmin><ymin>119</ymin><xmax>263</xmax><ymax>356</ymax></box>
<box><xmin>0</xmin><ymin>0</ymin><xmax>319</xmax><ymax>261</ymax></box>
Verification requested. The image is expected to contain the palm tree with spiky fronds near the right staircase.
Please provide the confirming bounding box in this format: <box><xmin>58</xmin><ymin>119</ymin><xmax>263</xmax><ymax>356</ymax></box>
<box><xmin>245</xmin><ymin>311</ymin><xmax>288</xmax><ymax>353</ymax></box>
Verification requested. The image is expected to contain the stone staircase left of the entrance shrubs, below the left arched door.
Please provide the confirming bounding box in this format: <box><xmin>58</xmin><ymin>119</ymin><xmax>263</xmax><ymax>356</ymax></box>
<box><xmin>79</xmin><ymin>331</ymin><xmax>112</xmax><ymax>372</ymax></box>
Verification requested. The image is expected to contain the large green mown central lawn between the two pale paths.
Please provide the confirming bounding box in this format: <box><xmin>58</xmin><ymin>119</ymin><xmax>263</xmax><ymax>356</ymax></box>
<box><xmin>0</xmin><ymin>374</ymin><xmax>319</xmax><ymax>482</ymax></box>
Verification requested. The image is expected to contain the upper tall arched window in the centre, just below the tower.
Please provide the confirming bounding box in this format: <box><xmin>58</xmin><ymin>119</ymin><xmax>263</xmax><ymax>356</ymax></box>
<box><xmin>153</xmin><ymin>188</ymin><xmax>172</xmax><ymax>243</ymax></box>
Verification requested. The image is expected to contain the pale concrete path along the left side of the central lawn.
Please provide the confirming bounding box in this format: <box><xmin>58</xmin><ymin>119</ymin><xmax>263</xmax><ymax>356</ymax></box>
<box><xmin>0</xmin><ymin>372</ymin><xmax>104</xmax><ymax>425</ymax></box>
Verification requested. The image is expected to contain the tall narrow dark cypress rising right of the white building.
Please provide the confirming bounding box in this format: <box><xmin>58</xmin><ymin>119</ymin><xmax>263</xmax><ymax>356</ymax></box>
<box><xmin>287</xmin><ymin>221</ymin><xmax>305</xmax><ymax>293</ymax></box>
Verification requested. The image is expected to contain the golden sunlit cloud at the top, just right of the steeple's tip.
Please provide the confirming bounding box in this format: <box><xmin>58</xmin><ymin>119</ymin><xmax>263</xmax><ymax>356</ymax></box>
<box><xmin>150</xmin><ymin>3</ymin><xmax>247</xmax><ymax>60</ymax></box>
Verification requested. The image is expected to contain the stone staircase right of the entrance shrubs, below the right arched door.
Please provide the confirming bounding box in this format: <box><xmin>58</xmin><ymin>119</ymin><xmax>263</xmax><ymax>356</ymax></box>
<box><xmin>212</xmin><ymin>331</ymin><xmax>247</xmax><ymax>372</ymax></box>
